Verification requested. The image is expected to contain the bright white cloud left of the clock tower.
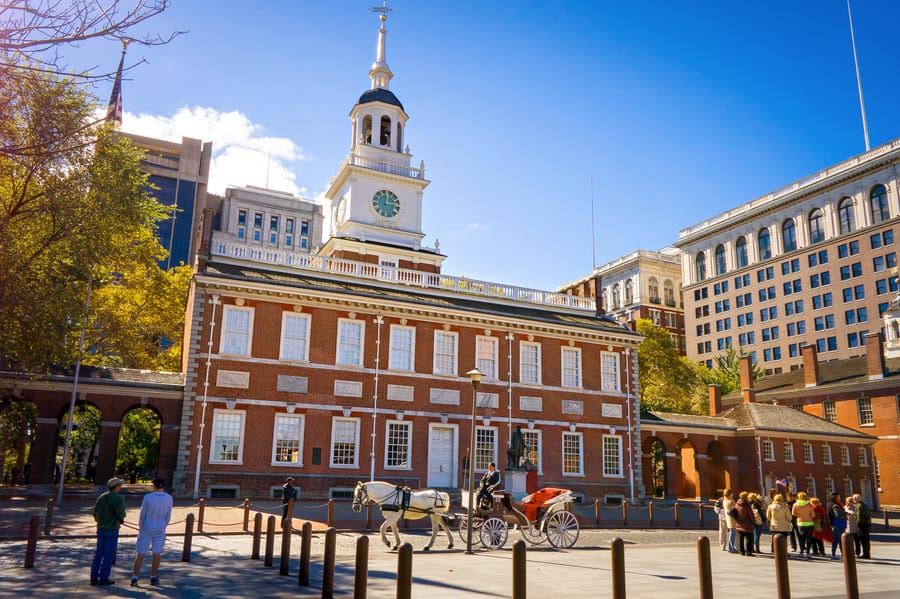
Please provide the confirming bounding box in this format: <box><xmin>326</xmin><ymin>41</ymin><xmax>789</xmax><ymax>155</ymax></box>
<box><xmin>122</xmin><ymin>106</ymin><xmax>306</xmax><ymax>196</ymax></box>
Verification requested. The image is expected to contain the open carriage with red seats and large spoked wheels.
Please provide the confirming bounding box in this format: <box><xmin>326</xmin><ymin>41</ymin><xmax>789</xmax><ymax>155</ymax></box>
<box><xmin>456</xmin><ymin>488</ymin><xmax>580</xmax><ymax>549</ymax></box>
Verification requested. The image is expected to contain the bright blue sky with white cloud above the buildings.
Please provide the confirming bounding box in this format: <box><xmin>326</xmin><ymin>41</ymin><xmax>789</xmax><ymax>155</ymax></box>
<box><xmin>67</xmin><ymin>0</ymin><xmax>900</xmax><ymax>289</ymax></box>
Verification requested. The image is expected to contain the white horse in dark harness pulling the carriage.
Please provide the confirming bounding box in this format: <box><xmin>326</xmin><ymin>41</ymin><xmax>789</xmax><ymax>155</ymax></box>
<box><xmin>353</xmin><ymin>481</ymin><xmax>453</xmax><ymax>551</ymax></box>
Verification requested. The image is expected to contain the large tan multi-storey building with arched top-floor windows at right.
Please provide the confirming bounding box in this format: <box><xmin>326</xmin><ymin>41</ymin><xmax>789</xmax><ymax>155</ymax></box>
<box><xmin>675</xmin><ymin>140</ymin><xmax>900</xmax><ymax>373</ymax></box>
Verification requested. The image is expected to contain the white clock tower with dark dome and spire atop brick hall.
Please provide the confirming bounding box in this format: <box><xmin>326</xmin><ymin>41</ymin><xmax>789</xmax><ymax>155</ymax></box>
<box><xmin>319</xmin><ymin>7</ymin><xmax>444</xmax><ymax>272</ymax></box>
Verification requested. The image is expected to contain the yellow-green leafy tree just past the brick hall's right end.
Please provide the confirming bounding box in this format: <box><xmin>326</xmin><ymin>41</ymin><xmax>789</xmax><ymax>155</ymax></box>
<box><xmin>635</xmin><ymin>318</ymin><xmax>700</xmax><ymax>414</ymax></box>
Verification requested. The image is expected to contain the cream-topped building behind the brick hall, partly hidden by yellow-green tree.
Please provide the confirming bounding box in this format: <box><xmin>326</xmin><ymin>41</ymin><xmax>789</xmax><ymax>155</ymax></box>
<box><xmin>557</xmin><ymin>247</ymin><xmax>685</xmax><ymax>355</ymax></box>
